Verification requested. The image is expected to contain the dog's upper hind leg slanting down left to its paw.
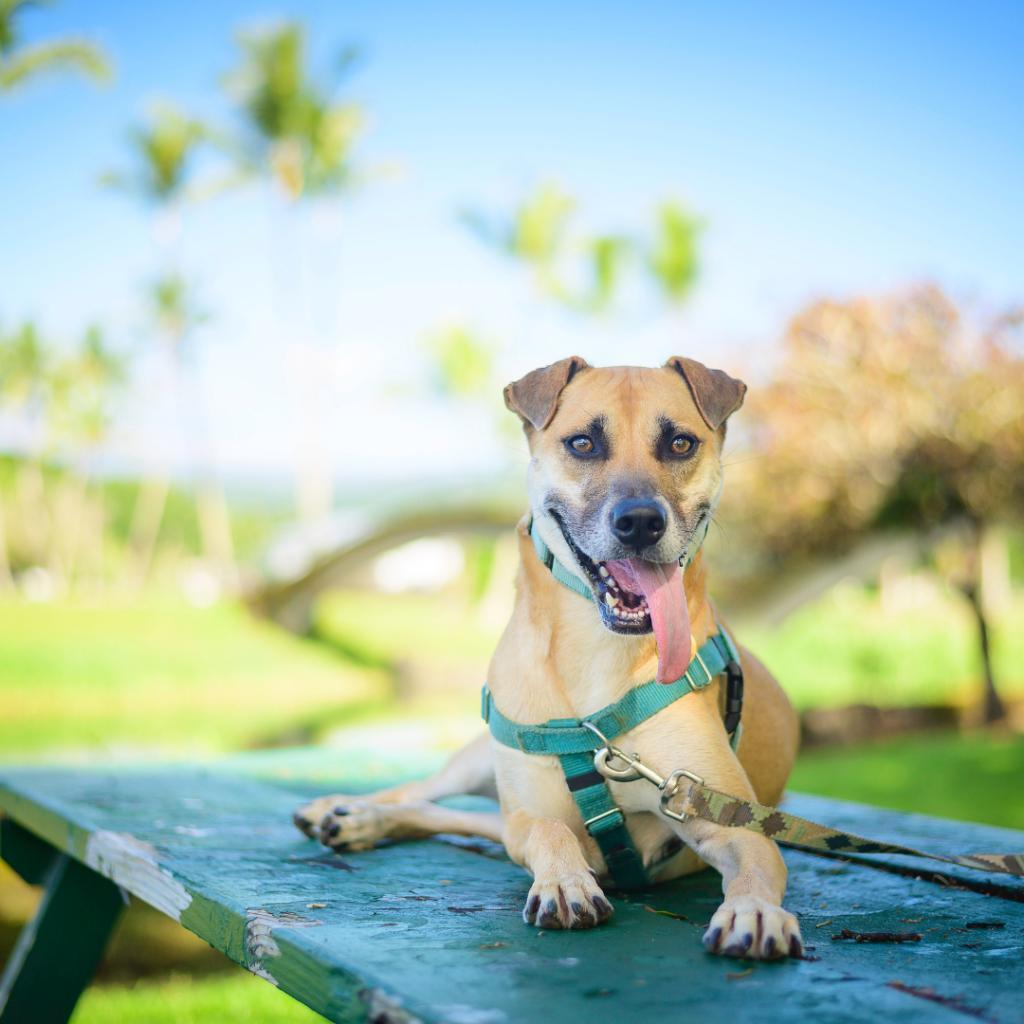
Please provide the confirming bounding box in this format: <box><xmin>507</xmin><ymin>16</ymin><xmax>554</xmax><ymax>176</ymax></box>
<box><xmin>293</xmin><ymin>733</ymin><xmax>497</xmax><ymax>839</ymax></box>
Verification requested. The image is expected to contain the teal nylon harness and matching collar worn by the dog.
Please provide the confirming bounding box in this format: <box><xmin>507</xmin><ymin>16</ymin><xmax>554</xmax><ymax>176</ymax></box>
<box><xmin>481</xmin><ymin>525</ymin><xmax>743</xmax><ymax>889</ymax></box>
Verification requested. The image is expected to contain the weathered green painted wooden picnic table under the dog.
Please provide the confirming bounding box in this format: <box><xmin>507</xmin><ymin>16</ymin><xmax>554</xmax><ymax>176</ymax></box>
<box><xmin>0</xmin><ymin>751</ymin><xmax>1024</xmax><ymax>1024</ymax></box>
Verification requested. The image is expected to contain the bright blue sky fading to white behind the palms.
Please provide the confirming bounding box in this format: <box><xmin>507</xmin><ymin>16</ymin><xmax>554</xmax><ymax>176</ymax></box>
<box><xmin>0</xmin><ymin>0</ymin><xmax>1024</xmax><ymax>487</ymax></box>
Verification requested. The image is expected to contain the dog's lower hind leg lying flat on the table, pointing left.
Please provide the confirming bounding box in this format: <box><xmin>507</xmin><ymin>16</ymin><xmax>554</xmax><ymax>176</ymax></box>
<box><xmin>319</xmin><ymin>801</ymin><xmax>502</xmax><ymax>851</ymax></box>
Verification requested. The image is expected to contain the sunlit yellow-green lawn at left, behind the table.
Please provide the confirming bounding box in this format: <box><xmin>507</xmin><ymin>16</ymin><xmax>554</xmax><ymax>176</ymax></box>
<box><xmin>0</xmin><ymin>599</ymin><xmax>385</xmax><ymax>760</ymax></box>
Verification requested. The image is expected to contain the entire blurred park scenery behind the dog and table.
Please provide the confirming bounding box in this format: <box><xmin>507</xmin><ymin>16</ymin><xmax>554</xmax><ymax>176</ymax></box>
<box><xmin>0</xmin><ymin>0</ymin><xmax>1024</xmax><ymax>1024</ymax></box>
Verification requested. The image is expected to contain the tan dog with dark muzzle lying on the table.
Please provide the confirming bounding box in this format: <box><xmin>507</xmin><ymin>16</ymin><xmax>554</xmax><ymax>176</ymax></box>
<box><xmin>295</xmin><ymin>357</ymin><xmax>802</xmax><ymax>958</ymax></box>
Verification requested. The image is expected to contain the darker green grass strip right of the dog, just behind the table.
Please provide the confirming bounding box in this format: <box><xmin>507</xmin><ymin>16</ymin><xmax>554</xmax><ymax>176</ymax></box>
<box><xmin>790</xmin><ymin>733</ymin><xmax>1024</xmax><ymax>828</ymax></box>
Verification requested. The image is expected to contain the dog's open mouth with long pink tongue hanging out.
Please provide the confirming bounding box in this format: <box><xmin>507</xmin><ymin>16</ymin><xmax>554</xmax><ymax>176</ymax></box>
<box><xmin>551</xmin><ymin>512</ymin><xmax>692</xmax><ymax>683</ymax></box>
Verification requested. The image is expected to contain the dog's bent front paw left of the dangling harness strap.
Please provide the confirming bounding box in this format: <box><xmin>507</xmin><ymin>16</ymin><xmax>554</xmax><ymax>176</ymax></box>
<box><xmin>505</xmin><ymin>810</ymin><xmax>611</xmax><ymax>929</ymax></box>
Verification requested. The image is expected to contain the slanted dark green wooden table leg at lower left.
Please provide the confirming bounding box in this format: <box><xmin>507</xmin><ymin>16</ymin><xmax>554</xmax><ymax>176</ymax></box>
<box><xmin>0</xmin><ymin>854</ymin><xmax>124</xmax><ymax>1024</ymax></box>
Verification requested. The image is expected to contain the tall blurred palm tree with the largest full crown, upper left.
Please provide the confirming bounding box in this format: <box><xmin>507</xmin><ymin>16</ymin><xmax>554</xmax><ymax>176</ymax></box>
<box><xmin>224</xmin><ymin>22</ymin><xmax>366</xmax><ymax>521</ymax></box>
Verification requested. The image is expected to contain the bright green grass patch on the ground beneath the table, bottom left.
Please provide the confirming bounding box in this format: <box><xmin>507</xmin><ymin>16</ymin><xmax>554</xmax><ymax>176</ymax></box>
<box><xmin>72</xmin><ymin>969</ymin><xmax>324</xmax><ymax>1024</ymax></box>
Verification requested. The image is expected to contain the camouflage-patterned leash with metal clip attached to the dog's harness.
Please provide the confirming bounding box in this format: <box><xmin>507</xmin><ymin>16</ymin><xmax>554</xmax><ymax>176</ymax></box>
<box><xmin>594</xmin><ymin>743</ymin><xmax>1024</xmax><ymax>878</ymax></box>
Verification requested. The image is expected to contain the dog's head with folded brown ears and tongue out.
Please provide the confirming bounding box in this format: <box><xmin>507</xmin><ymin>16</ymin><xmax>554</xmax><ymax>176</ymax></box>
<box><xmin>505</xmin><ymin>356</ymin><xmax>746</xmax><ymax>682</ymax></box>
